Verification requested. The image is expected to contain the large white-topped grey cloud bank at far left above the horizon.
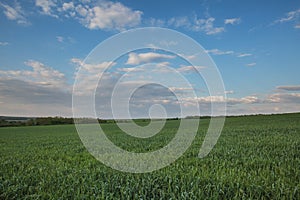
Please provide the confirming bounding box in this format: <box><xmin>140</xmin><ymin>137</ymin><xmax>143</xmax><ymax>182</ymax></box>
<box><xmin>0</xmin><ymin>60</ymin><xmax>72</xmax><ymax>116</ymax></box>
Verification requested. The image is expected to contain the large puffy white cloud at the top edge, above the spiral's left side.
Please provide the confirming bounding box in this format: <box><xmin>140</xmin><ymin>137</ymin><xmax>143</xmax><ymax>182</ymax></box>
<box><xmin>76</xmin><ymin>2</ymin><xmax>142</xmax><ymax>31</ymax></box>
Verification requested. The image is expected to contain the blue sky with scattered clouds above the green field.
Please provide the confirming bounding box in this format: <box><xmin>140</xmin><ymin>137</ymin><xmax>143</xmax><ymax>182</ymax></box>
<box><xmin>0</xmin><ymin>0</ymin><xmax>300</xmax><ymax>118</ymax></box>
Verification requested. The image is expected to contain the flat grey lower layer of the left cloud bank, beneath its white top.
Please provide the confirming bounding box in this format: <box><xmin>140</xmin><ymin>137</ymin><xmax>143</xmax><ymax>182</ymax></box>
<box><xmin>0</xmin><ymin>77</ymin><xmax>72</xmax><ymax>116</ymax></box>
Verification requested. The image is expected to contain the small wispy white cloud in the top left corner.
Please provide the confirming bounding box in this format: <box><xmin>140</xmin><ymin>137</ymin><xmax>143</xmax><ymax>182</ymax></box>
<box><xmin>0</xmin><ymin>3</ymin><xmax>29</xmax><ymax>25</ymax></box>
